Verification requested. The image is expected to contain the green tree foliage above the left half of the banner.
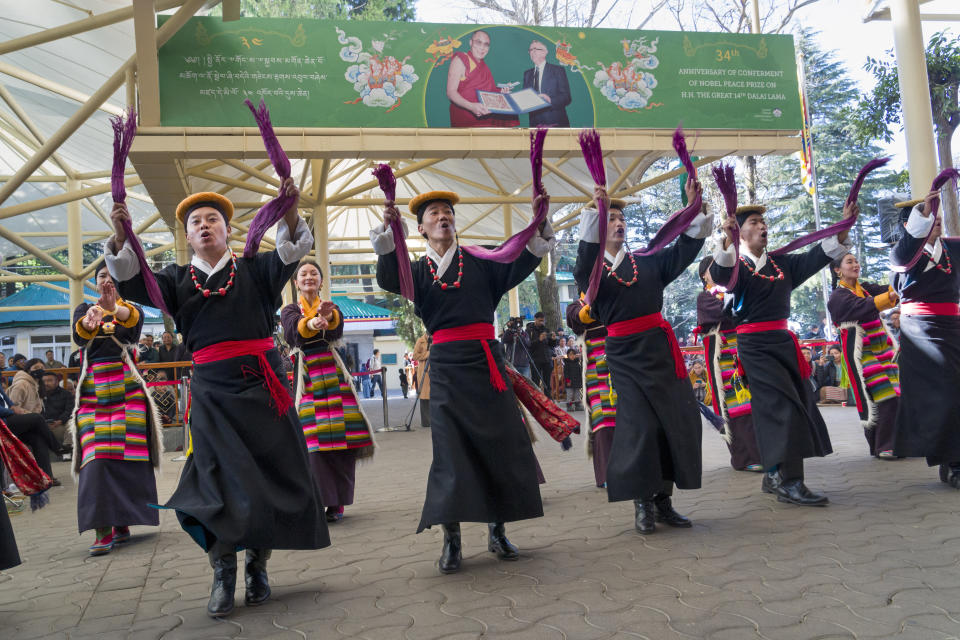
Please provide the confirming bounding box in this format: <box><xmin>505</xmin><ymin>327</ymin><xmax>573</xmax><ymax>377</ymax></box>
<box><xmin>211</xmin><ymin>0</ymin><xmax>416</xmax><ymax>22</ymax></box>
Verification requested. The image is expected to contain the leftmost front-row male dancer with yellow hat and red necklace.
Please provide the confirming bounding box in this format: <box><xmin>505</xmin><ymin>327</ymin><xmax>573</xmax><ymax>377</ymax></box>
<box><xmin>106</xmin><ymin>178</ymin><xmax>330</xmax><ymax>617</ymax></box>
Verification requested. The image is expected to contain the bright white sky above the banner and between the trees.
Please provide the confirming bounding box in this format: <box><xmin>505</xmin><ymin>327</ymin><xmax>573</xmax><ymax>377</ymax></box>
<box><xmin>417</xmin><ymin>0</ymin><xmax>960</xmax><ymax>167</ymax></box>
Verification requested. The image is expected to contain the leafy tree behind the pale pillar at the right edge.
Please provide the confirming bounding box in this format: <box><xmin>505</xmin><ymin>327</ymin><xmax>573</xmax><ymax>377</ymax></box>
<box><xmin>851</xmin><ymin>31</ymin><xmax>960</xmax><ymax>236</ymax></box>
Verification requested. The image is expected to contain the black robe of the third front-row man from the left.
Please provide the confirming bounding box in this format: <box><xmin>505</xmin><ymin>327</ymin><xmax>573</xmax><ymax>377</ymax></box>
<box><xmin>573</xmin><ymin>235</ymin><xmax>703</xmax><ymax>502</ymax></box>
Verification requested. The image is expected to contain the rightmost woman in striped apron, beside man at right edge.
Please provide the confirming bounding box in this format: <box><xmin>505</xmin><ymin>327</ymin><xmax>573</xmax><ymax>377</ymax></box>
<box><xmin>827</xmin><ymin>253</ymin><xmax>900</xmax><ymax>459</ymax></box>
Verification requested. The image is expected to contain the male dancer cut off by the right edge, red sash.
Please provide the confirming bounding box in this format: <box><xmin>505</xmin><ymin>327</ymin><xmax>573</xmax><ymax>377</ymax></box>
<box><xmin>890</xmin><ymin>191</ymin><xmax>960</xmax><ymax>489</ymax></box>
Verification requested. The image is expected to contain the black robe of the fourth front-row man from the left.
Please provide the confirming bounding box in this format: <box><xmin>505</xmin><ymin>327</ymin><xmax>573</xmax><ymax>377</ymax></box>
<box><xmin>710</xmin><ymin>244</ymin><xmax>833</xmax><ymax>469</ymax></box>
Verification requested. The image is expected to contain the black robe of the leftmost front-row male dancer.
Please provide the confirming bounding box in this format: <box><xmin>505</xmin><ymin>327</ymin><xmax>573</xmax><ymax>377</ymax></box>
<box><xmin>119</xmin><ymin>251</ymin><xmax>330</xmax><ymax>550</ymax></box>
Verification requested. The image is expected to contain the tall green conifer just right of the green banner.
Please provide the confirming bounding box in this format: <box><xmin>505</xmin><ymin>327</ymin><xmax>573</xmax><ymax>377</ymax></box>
<box><xmin>758</xmin><ymin>31</ymin><xmax>899</xmax><ymax>326</ymax></box>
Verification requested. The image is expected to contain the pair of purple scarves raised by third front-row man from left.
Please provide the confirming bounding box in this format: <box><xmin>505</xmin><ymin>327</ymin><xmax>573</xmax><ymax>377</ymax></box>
<box><xmin>580</xmin><ymin>126</ymin><xmax>703</xmax><ymax>304</ymax></box>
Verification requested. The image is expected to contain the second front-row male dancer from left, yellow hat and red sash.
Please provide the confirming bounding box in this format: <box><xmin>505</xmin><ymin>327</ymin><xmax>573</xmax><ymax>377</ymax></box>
<box><xmin>370</xmin><ymin>191</ymin><xmax>555</xmax><ymax>573</ymax></box>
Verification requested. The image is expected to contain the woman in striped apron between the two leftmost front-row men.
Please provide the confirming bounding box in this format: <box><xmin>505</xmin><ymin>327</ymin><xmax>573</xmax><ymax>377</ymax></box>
<box><xmin>280</xmin><ymin>260</ymin><xmax>373</xmax><ymax>522</ymax></box>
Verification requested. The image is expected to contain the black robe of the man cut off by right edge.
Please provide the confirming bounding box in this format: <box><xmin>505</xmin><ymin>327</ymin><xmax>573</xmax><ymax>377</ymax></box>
<box><xmin>890</xmin><ymin>233</ymin><xmax>960</xmax><ymax>466</ymax></box>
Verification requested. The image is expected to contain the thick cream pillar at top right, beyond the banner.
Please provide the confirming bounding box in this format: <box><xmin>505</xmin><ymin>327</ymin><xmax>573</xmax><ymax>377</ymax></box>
<box><xmin>890</xmin><ymin>0</ymin><xmax>937</xmax><ymax>198</ymax></box>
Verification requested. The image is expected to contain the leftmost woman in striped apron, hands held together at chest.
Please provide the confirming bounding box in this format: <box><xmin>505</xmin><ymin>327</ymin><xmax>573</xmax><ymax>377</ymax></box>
<box><xmin>70</xmin><ymin>264</ymin><xmax>162</xmax><ymax>556</ymax></box>
